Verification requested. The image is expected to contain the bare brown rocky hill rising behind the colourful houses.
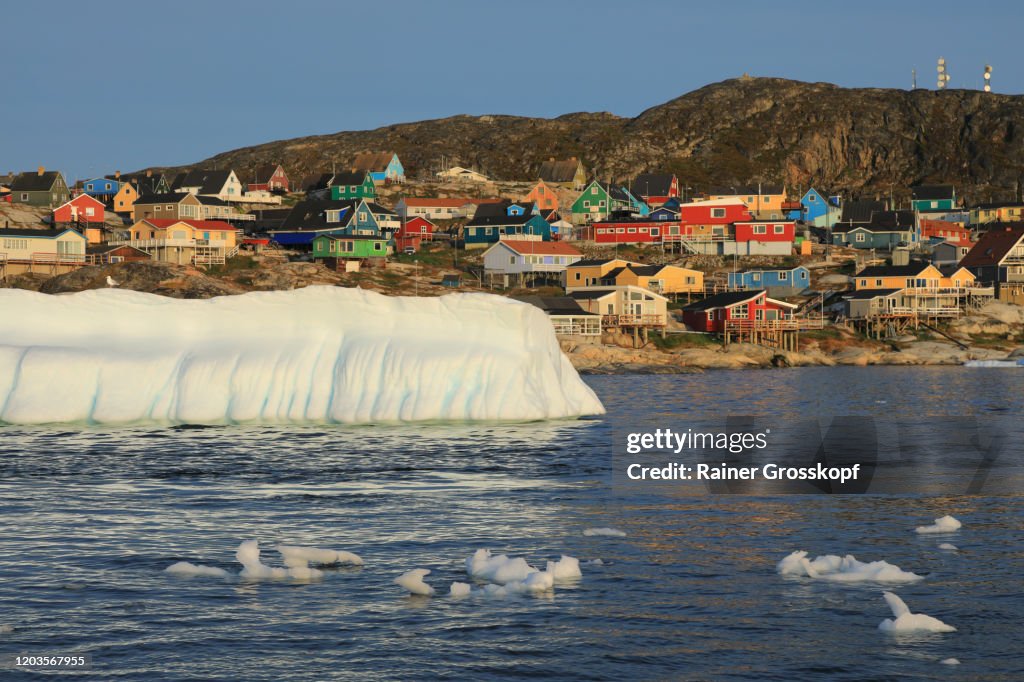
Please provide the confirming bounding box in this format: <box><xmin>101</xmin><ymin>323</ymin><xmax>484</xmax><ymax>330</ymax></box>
<box><xmin>151</xmin><ymin>77</ymin><xmax>1024</xmax><ymax>201</ymax></box>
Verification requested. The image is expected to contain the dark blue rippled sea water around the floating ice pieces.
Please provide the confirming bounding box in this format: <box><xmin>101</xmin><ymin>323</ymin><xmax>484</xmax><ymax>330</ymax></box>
<box><xmin>0</xmin><ymin>368</ymin><xmax>1024</xmax><ymax>680</ymax></box>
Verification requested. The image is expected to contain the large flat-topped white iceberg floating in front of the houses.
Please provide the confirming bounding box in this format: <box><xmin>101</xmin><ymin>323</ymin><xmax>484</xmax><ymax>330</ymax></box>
<box><xmin>0</xmin><ymin>287</ymin><xmax>604</xmax><ymax>424</ymax></box>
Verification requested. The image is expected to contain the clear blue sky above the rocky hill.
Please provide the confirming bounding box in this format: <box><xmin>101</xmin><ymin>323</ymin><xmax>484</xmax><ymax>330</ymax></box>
<box><xmin>0</xmin><ymin>0</ymin><xmax>1024</xmax><ymax>180</ymax></box>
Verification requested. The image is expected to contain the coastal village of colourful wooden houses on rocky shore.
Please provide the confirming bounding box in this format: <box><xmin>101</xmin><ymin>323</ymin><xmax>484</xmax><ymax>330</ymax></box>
<box><xmin>0</xmin><ymin>152</ymin><xmax>1024</xmax><ymax>371</ymax></box>
